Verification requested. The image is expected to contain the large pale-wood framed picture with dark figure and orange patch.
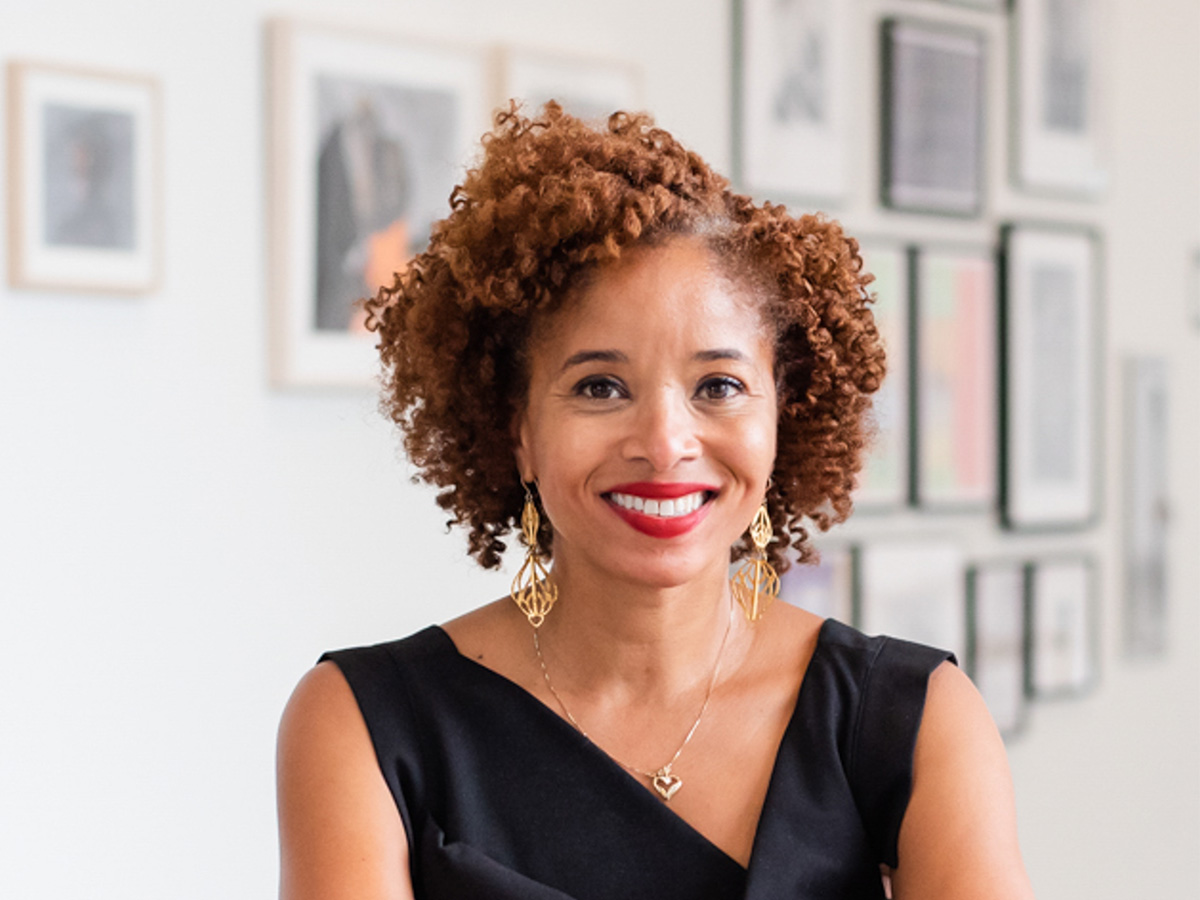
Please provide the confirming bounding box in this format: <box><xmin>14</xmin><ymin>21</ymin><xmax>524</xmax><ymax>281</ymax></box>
<box><xmin>269</xmin><ymin>20</ymin><xmax>488</xmax><ymax>386</ymax></box>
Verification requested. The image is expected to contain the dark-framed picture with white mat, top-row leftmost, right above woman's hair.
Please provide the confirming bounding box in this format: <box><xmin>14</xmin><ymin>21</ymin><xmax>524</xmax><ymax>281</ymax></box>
<box><xmin>733</xmin><ymin>0</ymin><xmax>853</xmax><ymax>203</ymax></box>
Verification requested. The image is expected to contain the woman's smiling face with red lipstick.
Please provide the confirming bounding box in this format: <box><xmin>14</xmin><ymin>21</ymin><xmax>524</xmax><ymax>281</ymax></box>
<box><xmin>517</xmin><ymin>239</ymin><xmax>778</xmax><ymax>587</ymax></box>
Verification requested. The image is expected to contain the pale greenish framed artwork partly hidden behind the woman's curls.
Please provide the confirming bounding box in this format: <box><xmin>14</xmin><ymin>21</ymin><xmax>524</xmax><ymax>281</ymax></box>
<box><xmin>854</xmin><ymin>241</ymin><xmax>910</xmax><ymax>511</ymax></box>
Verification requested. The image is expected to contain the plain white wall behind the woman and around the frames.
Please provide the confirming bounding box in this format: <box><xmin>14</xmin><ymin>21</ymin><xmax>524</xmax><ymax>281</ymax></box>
<box><xmin>0</xmin><ymin>0</ymin><xmax>1200</xmax><ymax>900</ymax></box>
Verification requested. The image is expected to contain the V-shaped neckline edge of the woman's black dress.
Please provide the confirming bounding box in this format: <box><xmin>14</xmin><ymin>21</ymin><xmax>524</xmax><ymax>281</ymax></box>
<box><xmin>430</xmin><ymin>619</ymin><xmax>833</xmax><ymax>874</ymax></box>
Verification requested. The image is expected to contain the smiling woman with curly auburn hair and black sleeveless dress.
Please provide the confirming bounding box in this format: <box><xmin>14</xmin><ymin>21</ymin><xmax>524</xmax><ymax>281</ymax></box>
<box><xmin>280</xmin><ymin>104</ymin><xmax>1030</xmax><ymax>900</ymax></box>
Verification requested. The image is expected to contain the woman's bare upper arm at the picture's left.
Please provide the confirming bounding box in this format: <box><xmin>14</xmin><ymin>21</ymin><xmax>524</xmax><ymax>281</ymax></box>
<box><xmin>276</xmin><ymin>662</ymin><xmax>413</xmax><ymax>900</ymax></box>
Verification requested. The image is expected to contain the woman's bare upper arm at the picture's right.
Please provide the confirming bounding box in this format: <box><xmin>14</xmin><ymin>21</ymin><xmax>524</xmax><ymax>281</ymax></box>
<box><xmin>892</xmin><ymin>662</ymin><xmax>1033</xmax><ymax>900</ymax></box>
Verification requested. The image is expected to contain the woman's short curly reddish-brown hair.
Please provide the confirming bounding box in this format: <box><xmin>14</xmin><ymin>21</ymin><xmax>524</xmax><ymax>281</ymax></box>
<box><xmin>366</xmin><ymin>102</ymin><xmax>884</xmax><ymax>570</ymax></box>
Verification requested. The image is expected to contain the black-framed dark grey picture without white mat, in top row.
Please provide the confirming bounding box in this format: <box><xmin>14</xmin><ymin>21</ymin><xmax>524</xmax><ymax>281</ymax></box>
<box><xmin>880</xmin><ymin>19</ymin><xmax>986</xmax><ymax>216</ymax></box>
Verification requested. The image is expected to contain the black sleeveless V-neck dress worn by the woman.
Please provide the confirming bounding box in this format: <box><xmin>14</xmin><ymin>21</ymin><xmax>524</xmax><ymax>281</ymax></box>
<box><xmin>322</xmin><ymin>619</ymin><xmax>953</xmax><ymax>900</ymax></box>
